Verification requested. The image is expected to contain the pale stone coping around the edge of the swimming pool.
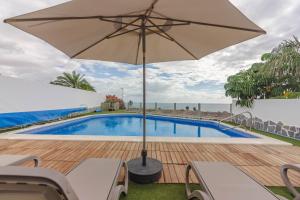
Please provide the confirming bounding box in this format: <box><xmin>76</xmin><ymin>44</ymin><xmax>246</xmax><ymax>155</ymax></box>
<box><xmin>0</xmin><ymin>113</ymin><xmax>292</xmax><ymax>145</ymax></box>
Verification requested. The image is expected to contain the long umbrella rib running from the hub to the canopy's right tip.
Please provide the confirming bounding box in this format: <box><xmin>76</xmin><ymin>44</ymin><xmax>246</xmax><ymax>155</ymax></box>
<box><xmin>149</xmin><ymin>16</ymin><xmax>266</xmax><ymax>34</ymax></box>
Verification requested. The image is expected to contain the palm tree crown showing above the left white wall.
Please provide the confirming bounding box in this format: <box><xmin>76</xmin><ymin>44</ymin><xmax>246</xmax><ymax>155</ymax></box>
<box><xmin>50</xmin><ymin>71</ymin><xmax>96</xmax><ymax>92</ymax></box>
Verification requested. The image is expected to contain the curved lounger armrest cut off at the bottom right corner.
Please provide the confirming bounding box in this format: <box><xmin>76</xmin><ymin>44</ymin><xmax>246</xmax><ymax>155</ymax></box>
<box><xmin>280</xmin><ymin>164</ymin><xmax>300</xmax><ymax>200</ymax></box>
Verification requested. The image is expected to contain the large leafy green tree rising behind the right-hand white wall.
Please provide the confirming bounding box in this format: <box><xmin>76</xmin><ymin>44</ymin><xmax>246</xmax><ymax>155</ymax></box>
<box><xmin>224</xmin><ymin>37</ymin><xmax>300</xmax><ymax>107</ymax></box>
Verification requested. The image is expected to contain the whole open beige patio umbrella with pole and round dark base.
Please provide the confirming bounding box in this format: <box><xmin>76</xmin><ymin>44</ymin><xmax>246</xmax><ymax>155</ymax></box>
<box><xmin>5</xmin><ymin>0</ymin><xmax>265</xmax><ymax>182</ymax></box>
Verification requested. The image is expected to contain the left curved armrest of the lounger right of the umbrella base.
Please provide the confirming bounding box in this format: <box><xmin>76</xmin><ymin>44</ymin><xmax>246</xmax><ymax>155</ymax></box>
<box><xmin>185</xmin><ymin>164</ymin><xmax>211</xmax><ymax>200</ymax></box>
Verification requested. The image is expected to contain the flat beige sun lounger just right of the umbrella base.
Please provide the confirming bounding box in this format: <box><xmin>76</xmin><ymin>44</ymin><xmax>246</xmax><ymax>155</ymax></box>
<box><xmin>186</xmin><ymin>161</ymin><xmax>284</xmax><ymax>200</ymax></box>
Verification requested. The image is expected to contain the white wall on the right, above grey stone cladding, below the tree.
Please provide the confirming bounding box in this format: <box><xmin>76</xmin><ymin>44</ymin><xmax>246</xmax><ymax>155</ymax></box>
<box><xmin>232</xmin><ymin>99</ymin><xmax>300</xmax><ymax>127</ymax></box>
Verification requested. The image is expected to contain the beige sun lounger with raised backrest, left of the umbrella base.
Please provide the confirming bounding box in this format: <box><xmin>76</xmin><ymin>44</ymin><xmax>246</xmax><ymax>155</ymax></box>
<box><xmin>0</xmin><ymin>159</ymin><xmax>128</xmax><ymax>200</ymax></box>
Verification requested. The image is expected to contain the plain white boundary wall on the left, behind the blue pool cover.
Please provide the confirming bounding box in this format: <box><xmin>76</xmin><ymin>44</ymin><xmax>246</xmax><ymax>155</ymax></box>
<box><xmin>0</xmin><ymin>76</ymin><xmax>104</xmax><ymax>113</ymax></box>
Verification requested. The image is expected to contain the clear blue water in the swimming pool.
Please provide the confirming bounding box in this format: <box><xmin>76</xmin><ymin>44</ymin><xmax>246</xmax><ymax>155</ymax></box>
<box><xmin>22</xmin><ymin>114</ymin><xmax>255</xmax><ymax>138</ymax></box>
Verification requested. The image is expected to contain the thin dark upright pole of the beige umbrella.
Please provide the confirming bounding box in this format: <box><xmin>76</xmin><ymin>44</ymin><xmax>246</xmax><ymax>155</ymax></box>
<box><xmin>141</xmin><ymin>15</ymin><xmax>147</xmax><ymax>166</ymax></box>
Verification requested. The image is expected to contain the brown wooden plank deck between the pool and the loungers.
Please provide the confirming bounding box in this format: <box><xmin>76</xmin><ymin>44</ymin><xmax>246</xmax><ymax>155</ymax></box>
<box><xmin>0</xmin><ymin>140</ymin><xmax>300</xmax><ymax>186</ymax></box>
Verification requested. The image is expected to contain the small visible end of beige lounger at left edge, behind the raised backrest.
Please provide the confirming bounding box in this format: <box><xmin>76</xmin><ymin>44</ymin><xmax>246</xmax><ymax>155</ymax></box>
<box><xmin>0</xmin><ymin>155</ymin><xmax>41</xmax><ymax>167</ymax></box>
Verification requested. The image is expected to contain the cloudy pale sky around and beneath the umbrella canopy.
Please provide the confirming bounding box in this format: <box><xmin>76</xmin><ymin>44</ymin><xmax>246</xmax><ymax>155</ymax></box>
<box><xmin>0</xmin><ymin>0</ymin><xmax>300</xmax><ymax>103</ymax></box>
